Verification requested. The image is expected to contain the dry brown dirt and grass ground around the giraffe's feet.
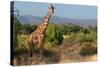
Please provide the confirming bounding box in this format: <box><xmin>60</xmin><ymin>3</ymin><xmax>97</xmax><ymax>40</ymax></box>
<box><xmin>13</xmin><ymin>44</ymin><xmax>97</xmax><ymax>65</ymax></box>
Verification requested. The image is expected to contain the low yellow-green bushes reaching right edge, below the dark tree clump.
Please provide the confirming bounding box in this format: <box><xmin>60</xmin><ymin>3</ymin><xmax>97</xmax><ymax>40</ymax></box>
<box><xmin>64</xmin><ymin>31</ymin><xmax>97</xmax><ymax>44</ymax></box>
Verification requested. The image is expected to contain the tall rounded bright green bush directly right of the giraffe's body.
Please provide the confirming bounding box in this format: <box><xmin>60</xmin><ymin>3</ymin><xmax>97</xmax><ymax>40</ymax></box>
<box><xmin>45</xmin><ymin>23</ymin><xmax>63</xmax><ymax>46</ymax></box>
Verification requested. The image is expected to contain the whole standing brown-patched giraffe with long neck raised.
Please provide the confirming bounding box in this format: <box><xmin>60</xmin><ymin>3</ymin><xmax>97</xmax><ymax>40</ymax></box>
<box><xmin>28</xmin><ymin>4</ymin><xmax>54</xmax><ymax>59</ymax></box>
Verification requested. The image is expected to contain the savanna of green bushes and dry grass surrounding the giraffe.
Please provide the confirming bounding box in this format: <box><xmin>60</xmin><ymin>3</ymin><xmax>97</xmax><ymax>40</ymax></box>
<box><xmin>13</xmin><ymin>17</ymin><xmax>97</xmax><ymax>65</ymax></box>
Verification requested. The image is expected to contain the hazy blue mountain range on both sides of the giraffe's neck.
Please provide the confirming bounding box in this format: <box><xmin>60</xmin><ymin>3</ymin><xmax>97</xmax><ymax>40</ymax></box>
<box><xmin>17</xmin><ymin>15</ymin><xmax>97</xmax><ymax>27</ymax></box>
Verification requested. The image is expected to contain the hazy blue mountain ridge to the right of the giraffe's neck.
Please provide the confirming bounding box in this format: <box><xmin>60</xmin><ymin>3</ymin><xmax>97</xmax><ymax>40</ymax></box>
<box><xmin>51</xmin><ymin>16</ymin><xmax>97</xmax><ymax>27</ymax></box>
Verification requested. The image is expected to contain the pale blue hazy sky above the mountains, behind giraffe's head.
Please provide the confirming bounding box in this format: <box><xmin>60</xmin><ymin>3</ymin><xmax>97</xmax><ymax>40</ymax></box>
<box><xmin>14</xmin><ymin>1</ymin><xmax>97</xmax><ymax>19</ymax></box>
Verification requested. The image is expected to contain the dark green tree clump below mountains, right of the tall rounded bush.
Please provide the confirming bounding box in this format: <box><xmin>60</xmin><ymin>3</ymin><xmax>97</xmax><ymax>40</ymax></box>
<box><xmin>58</xmin><ymin>23</ymin><xmax>84</xmax><ymax>35</ymax></box>
